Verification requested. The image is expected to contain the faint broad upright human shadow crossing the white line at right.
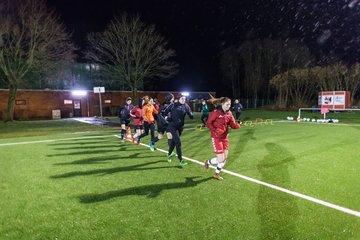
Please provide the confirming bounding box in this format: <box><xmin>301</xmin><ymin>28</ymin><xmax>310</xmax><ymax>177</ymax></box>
<box><xmin>257</xmin><ymin>143</ymin><xmax>299</xmax><ymax>239</ymax></box>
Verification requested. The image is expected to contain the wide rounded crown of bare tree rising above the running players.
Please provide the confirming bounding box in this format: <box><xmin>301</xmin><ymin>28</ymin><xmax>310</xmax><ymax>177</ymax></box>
<box><xmin>87</xmin><ymin>14</ymin><xmax>178</xmax><ymax>96</ymax></box>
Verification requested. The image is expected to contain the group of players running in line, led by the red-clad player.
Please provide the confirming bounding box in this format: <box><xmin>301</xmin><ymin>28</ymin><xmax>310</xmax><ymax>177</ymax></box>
<box><xmin>119</xmin><ymin>93</ymin><xmax>240</xmax><ymax>180</ymax></box>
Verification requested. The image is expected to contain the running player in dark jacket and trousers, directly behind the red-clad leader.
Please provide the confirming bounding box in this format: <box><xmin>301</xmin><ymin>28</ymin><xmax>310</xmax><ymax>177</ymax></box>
<box><xmin>166</xmin><ymin>96</ymin><xmax>194</xmax><ymax>167</ymax></box>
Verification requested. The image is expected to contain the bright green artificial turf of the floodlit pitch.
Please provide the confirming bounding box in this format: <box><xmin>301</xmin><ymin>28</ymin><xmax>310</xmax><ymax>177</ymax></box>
<box><xmin>0</xmin><ymin>111</ymin><xmax>360</xmax><ymax>240</ymax></box>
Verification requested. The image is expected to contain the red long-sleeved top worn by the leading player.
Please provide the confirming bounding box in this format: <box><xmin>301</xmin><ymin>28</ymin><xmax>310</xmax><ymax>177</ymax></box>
<box><xmin>206</xmin><ymin>109</ymin><xmax>240</xmax><ymax>138</ymax></box>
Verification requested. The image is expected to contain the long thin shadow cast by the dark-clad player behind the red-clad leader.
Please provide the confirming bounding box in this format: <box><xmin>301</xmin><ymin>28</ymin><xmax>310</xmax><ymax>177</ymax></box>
<box><xmin>50</xmin><ymin>161</ymin><xmax>181</xmax><ymax>178</ymax></box>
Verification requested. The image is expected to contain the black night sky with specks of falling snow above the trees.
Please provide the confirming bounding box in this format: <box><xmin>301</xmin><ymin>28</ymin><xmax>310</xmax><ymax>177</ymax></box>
<box><xmin>47</xmin><ymin>0</ymin><xmax>360</xmax><ymax>92</ymax></box>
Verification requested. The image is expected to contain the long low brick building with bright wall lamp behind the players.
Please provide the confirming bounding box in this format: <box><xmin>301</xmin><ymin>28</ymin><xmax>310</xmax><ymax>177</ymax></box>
<box><xmin>0</xmin><ymin>89</ymin><xmax>215</xmax><ymax>120</ymax></box>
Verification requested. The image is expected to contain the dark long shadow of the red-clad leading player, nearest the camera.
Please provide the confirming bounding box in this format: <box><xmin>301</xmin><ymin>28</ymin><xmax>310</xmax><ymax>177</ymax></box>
<box><xmin>79</xmin><ymin>176</ymin><xmax>212</xmax><ymax>203</ymax></box>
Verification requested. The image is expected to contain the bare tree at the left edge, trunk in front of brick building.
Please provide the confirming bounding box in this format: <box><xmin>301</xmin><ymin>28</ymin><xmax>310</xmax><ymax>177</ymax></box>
<box><xmin>0</xmin><ymin>0</ymin><xmax>74</xmax><ymax>121</ymax></box>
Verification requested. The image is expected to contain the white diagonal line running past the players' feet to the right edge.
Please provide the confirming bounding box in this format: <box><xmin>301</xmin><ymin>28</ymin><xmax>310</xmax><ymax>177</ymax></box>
<box><xmin>115</xmin><ymin>135</ymin><xmax>360</xmax><ymax>217</ymax></box>
